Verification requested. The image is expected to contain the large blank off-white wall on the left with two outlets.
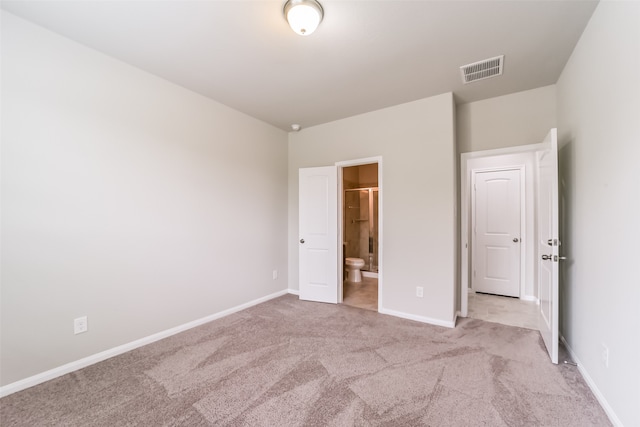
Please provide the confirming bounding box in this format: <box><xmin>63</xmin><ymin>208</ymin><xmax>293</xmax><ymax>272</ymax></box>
<box><xmin>0</xmin><ymin>12</ymin><xmax>287</xmax><ymax>385</ymax></box>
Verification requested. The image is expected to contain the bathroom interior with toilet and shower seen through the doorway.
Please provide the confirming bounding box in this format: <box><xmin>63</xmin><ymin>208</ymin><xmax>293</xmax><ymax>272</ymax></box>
<box><xmin>341</xmin><ymin>162</ymin><xmax>380</xmax><ymax>311</ymax></box>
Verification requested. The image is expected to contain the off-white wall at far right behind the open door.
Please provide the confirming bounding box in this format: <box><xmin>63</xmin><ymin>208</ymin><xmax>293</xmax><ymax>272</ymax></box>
<box><xmin>557</xmin><ymin>1</ymin><xmax>640</xmax><ymax>426</ymax></box>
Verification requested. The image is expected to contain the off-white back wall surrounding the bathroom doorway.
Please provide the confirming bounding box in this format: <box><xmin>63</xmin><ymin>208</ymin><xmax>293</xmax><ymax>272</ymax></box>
<box><xmin>289</xmin><ymin>93</ymin><xmax>457</xmax><ymax>322</ymax></box>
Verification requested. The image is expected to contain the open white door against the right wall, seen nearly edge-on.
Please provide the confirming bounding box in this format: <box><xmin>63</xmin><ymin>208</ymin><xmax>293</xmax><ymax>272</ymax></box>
<box><xmin>537</xmin><ymin>129</ymin><xmax>560</xmax><ymax>363</ymax></box>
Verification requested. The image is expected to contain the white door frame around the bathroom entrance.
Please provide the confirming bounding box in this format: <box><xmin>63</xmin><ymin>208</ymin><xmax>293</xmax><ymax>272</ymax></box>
<box><xmin>335</xmin><ymin>156</ymin><xmax>384</xmax><ymax>313</ymax></box>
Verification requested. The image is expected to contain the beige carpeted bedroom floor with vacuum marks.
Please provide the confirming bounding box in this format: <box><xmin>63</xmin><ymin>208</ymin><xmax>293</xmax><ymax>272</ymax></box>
<box><xmin>0</xmin><ymin>295</ymin><xmax>610</xmax><ymax>427</ymax></box>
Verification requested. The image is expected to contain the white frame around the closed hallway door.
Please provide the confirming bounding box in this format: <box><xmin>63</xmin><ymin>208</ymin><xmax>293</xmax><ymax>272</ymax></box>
<box><xmin>469</xmin><ymin>164</ymin><xmax>528</xmax><ymax>299</ymax></box>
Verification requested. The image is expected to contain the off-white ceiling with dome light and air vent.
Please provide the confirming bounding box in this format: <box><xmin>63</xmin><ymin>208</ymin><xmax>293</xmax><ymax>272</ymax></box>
<box><xmin>2</xmin><ymin>0</ymin><xmax>597</xmax><ymax>130</ymax></box>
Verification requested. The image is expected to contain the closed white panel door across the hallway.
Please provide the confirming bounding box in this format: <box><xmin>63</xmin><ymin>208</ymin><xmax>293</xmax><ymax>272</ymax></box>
<box><xmin>472</xmin><ymin>169</ymin><xmax>521</xmax><ymax>297</ymax></box>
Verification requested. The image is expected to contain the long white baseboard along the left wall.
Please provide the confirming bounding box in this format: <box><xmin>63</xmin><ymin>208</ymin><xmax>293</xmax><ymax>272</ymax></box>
<box><xmin>0</xmin><ymin>289</ymin><xmax>291</xmax><ymax>397</ymax></box>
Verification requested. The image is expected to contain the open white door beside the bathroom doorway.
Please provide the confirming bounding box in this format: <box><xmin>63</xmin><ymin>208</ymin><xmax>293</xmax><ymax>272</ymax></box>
<box><xmin>298</xmin><ymin>166</ymin><xmax>338</xmax><ymax>304</ymax></box>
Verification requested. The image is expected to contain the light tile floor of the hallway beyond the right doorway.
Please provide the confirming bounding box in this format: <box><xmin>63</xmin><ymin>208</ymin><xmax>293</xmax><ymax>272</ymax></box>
<box><xmin>467</xmin><ymin>293</ymin><xmax>540</xmax><ymax>329</ymax></box>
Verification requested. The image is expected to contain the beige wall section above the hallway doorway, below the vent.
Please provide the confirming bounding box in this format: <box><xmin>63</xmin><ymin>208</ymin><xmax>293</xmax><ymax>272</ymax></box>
<box><xmin>456</xmin><ymin>85</ymin><xmax>556</xmax><ymax>153</ymax></box>
